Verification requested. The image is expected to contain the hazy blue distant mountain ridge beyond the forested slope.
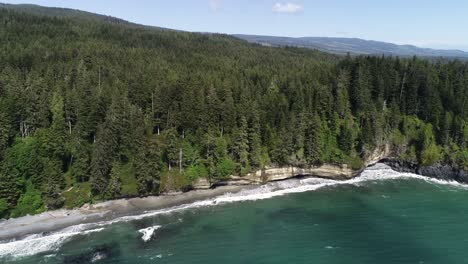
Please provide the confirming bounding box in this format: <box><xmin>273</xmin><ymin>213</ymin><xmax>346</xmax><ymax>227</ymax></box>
<box><xmin>234</xmin><ymin>35</ymin><xmax>468</xmax><ymax>58</ymax></box>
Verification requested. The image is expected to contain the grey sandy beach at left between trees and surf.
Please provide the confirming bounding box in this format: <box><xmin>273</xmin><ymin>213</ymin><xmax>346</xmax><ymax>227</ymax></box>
<box><xmin>0</xmin><ymin>185</ymin><xmax>250</xmax><ymax>241</ymax></box>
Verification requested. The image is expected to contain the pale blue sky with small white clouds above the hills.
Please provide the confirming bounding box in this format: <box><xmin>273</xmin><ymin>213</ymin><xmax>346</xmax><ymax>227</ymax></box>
<box><xmin>0</xmin><ymin>0</ymin><xmax>468</xmax><ymax>51</ymax></box>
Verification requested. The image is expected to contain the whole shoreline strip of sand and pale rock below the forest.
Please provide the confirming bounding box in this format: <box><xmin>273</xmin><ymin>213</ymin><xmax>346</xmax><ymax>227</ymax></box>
<box><xmin>0</xmin><ymin>155</ymin><xmax>466</xmax><ymax>243</ymax></box>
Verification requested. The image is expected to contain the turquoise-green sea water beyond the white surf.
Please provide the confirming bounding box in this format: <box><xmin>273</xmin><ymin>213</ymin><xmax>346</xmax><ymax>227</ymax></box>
<box><xmin>0</xmin><ymin>166</ymin><xmax>468</xmax><ymax>264</ymax></box>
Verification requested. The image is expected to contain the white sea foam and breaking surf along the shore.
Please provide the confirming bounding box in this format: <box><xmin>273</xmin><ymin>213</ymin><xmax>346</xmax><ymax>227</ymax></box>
<box><xmin>0</xmin><ymin>164</ymin><xmax>468</xmax><ymax>258</ymax></box>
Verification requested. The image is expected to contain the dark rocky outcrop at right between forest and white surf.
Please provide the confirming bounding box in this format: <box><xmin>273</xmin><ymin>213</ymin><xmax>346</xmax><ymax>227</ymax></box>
<box><xmin>382</xmin><ymin>159</ymin><xmax>468</xmax><ymax>183</ymax></box>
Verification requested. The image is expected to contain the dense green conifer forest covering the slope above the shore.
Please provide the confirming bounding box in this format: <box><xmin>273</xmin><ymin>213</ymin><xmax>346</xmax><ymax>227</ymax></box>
<box><xmin>0</xmin><ymin>9</ymin><xmax>468</xmax><ymax>217</ymax></box>
